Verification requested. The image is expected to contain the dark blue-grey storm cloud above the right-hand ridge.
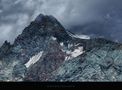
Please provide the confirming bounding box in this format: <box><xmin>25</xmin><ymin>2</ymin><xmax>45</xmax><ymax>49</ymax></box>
<box><xmin>70</xmin><ymin>0</ymin><xmax>122</xmax><ymax>42</ymax></box>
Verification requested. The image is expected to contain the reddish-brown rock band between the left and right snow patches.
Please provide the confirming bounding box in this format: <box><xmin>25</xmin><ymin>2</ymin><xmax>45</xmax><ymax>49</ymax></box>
<box><xmin>25</xmin><ymin>39</ymin><xmax>66</xmax><ymax>81</ymax></box>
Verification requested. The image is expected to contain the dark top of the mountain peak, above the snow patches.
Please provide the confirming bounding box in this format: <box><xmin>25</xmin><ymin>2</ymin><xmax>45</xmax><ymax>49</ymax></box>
<box><xmin>15</xmin><ymin>14</ymin><xmax>70</xmax><ymax>42</ymax></box>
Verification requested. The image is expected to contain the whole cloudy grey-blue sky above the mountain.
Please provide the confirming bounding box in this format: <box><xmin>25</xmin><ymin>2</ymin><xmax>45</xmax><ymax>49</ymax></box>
<box><xmin>0</xmin><ymin>0</ymin><xmax>122</xmax><ymax>45</ymax></box>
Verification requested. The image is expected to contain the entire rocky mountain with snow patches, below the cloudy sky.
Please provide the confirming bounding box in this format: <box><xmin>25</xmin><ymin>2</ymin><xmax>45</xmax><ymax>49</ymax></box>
<box><xmin>0</xmin><ymin>14</ymin><xmax>122</xmax><ymax>82</ymax></box>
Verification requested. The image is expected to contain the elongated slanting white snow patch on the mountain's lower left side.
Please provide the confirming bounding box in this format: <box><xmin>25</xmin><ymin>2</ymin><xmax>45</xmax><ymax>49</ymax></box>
<box><xmin>25</xmin><ymin>51</ymin><xmax>43</xmax><ymax>68</ymax></box>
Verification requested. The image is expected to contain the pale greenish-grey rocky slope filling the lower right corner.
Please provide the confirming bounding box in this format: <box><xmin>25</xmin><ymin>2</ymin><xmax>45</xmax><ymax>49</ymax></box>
<box><xmin>50</xmin><ymin>43</ymin><xmax>122</xmax><ymax>82</ymax></box>
